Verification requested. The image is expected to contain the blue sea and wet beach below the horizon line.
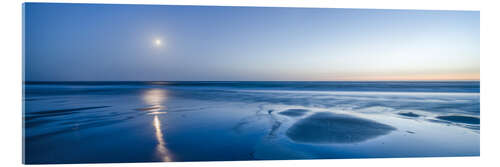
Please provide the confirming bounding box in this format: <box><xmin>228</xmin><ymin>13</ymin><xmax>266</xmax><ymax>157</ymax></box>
<box><xmin>23</xmin><ymin>82</ymin><xmax>480</xmax><ymax>164</ymax></box>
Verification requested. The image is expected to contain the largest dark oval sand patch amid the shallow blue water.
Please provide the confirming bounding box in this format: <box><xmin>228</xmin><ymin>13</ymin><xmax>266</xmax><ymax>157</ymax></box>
<box><xmin>286</xmin><ymin>112</ymin><xmax>395</xmax><ymax>143</ymax></box>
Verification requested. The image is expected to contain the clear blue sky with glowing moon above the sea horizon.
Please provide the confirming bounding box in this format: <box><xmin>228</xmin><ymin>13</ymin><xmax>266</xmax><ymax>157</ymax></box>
<box><xmin>24</xmin><ymin>3</ymin><xmax>480</xmax><ymax>81</ymax></box>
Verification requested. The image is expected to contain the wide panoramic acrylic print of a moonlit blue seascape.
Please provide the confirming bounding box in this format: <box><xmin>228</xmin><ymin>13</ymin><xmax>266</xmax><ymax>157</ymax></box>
<box><xmin>23</xmin><ymin>3</ymin><xmax>480</xmax><ymax>164</ymax></box>
